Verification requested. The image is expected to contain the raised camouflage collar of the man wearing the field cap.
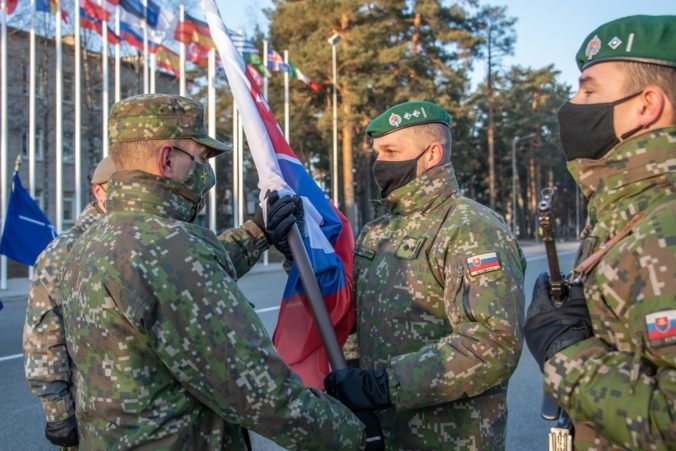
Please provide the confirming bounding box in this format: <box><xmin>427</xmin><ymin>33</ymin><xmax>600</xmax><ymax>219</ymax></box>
<box><xmin>106</xmin><ymin>170</ymin><xmax>199</xmax><ymax>222</ymax></box>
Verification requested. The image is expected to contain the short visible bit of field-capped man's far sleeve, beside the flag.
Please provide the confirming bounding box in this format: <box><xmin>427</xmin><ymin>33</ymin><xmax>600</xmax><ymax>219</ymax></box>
<box><xmin>218</xmin><ymin>221</ymin><xmax>270</xmax><ymax>279</ymax></box>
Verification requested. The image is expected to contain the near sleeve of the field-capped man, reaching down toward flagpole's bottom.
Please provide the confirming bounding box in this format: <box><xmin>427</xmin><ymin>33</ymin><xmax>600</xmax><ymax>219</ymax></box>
<box><xmin>142</xmin><ymin>237</ymin><xmax>363</xmax><ymax>449</ymax></box>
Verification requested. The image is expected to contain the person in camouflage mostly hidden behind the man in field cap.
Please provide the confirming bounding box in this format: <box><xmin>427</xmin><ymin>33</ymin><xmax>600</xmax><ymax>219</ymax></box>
<box><xmin>23</xmin><ymin>158</ymin><xmax>115</xmax><ymax>446</ymax></box>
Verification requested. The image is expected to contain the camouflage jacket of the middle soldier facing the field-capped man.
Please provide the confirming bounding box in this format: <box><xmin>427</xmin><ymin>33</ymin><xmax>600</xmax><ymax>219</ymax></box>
<box><xmin>354</xmin><ymin>164</ymin><xmax>526</xmax><ymax>450</ymax></box>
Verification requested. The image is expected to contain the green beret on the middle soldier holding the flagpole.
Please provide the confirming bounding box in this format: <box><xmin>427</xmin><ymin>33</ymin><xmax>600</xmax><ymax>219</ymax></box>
<box><xmin>366</xmin><ymin>101</ymin><xmax>451</xmax><ymax>138</ymax></box>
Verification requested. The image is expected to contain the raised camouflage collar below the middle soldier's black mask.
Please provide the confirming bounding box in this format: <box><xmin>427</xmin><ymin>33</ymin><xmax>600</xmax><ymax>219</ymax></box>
<box><xmin>383</xmin><ymin>163</ymin><xmax>458</xmax><ymax>216</ymax></box>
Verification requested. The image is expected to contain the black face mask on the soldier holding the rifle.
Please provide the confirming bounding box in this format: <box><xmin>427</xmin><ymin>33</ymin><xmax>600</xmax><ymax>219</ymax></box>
<box><xmin>558</xmin><ymin>91</ymin><xmax>645</xmax><ymax>161</ymax></box>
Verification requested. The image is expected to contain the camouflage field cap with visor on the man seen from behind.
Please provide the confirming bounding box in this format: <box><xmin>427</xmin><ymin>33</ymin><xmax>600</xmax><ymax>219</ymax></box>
<box><xmin>108</xmin><ymin>94</ymin><xmax>227</xmax><ymax>158</ymax></box>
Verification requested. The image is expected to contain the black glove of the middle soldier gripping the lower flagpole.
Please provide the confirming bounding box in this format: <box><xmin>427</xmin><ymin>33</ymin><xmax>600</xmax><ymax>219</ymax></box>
<box><xmin>324</xmin><ymin>367</ymin><xmax>392</xmax><ymax>411</ymax></box>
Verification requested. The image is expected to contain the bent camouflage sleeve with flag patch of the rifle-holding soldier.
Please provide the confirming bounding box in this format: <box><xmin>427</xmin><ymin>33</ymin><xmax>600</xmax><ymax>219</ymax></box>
<box><xmin>544</xmin><ymin>215</ymin><xmax>676</xmax><ymax>449</ymax></box>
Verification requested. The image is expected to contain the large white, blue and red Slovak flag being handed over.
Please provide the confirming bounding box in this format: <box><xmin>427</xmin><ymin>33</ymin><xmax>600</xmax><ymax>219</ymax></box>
<box><xmin>204</xmin><ymin>0</ymin><xmax>355</xmax><ymax>389</ymax></box>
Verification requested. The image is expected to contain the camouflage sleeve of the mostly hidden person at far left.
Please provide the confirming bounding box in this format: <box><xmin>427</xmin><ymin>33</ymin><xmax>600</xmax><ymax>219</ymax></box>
<box><xmin>23</xmin><ymin>248</ymin><xmax>75</xmax><ymax>421</ymax></box>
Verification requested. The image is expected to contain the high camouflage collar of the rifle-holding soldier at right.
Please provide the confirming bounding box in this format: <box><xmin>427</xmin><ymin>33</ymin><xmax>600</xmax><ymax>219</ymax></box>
<box><xmin>568</xmin><ymin>126</ymin><xmax>676</xmax><ymax>233</ymax></box>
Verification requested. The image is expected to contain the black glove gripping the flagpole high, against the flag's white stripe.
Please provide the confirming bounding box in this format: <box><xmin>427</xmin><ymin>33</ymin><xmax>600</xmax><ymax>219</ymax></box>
<box><xmin>253</xmin><ymin>191</ymin><xmax>305</xmax><ymax>261</ymax></box>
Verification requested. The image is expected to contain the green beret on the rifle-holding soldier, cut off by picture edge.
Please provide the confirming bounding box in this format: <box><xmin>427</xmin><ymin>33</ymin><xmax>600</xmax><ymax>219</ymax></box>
<box><xmin>576</xmin><ymin>16</ymin><xmax>676</xmax><ymax>71</ymax></box>
